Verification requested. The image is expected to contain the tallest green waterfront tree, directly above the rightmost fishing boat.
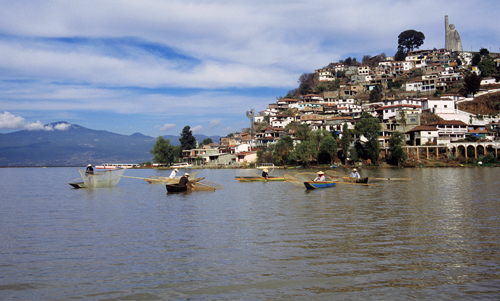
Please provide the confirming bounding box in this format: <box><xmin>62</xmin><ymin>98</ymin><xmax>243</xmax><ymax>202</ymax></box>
<box><xmin>354</xmin><ymin>112</ymin><xmax>382</xmax><ymax>162</ymax></box>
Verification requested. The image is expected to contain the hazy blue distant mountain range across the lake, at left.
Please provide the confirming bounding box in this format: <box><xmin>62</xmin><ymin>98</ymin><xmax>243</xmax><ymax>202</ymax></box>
<box><xmin>0</xmin><ymin>121</ymin><xmax>220</xmax><ymax>167</ymax></box>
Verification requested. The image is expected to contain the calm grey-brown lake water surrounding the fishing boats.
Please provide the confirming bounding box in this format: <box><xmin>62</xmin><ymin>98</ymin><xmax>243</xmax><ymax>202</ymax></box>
<box><xmin>0</xmin><ymin>168</ymin><xmax>500</xmax><ymax>300</ymax></box>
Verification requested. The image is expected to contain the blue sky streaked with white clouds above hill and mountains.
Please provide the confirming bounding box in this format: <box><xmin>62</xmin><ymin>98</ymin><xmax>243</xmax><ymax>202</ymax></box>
<box><xmin>0</xmin><ymin>0</ymin><xmax>500</xmax><ymax>137</ymax></box>
